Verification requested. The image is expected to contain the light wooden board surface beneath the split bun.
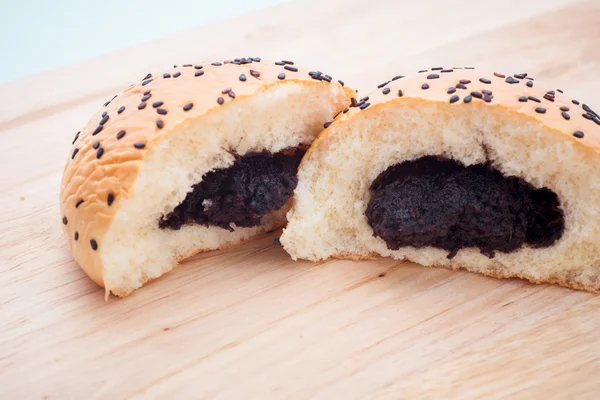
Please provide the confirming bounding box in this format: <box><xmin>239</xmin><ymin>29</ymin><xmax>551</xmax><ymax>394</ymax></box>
<box><xmin>0</xmin><ymin>0</ymin><xmax>600</xmax><ymax>399</ymax></box>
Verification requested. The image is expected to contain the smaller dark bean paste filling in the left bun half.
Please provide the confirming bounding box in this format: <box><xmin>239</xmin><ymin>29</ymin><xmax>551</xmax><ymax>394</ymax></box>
<box><xmin>159</xmin><ymin>148</ymin><xmax>305</xmax><ymax>231</ymax></box>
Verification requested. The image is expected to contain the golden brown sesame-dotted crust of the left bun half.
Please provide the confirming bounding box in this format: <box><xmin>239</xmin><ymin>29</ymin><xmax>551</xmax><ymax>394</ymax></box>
<box><xmin>60</xmin><ymin>59</ymin><xmax>354</xmax><ymax>286</ymax></box>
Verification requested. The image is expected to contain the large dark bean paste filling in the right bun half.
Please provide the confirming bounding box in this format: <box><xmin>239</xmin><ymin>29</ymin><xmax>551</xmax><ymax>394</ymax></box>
<box><xmin>365</xmin><ymin>156</ymin><xmax>565</xmax><ymax>259</ymax></box>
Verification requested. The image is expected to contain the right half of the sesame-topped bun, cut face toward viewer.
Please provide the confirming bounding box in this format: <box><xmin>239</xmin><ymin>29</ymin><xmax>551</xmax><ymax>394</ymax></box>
<box><xmin>281</xmin><ymin>68</ymin><xmax>600</xmax><ymax>291</ymax></box>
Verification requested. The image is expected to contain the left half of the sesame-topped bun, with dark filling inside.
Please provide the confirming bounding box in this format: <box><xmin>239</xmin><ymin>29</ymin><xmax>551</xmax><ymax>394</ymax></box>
<box><xmin>60</xmin><ymin>58</ymin><xmax>354</xmax><ymax>296</ymax></box>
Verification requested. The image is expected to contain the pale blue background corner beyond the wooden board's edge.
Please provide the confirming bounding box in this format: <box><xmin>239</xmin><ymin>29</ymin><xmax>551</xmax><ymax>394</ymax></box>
<box><xmin>0</xmin><ymin>0</ymin><xmax>284</xmax><ymax>83</ymax></box>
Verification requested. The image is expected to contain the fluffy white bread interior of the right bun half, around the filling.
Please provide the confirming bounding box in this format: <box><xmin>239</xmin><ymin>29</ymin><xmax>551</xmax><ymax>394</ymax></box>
<box><xmin>281</xmin><ymin>97</ymin><xmax>600</xmax><ymax>291</ymax></box>
